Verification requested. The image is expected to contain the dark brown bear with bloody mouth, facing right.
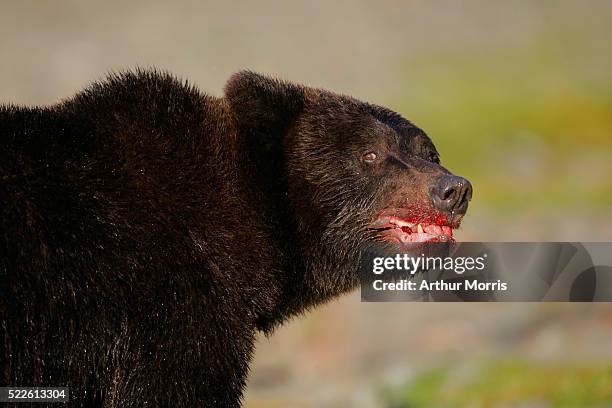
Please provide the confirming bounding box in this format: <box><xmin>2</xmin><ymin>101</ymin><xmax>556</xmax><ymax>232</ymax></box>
<box><xmin>0</xmin><ymin>71</ymin><xmax>471</xmax><ymax>407</ymax></box>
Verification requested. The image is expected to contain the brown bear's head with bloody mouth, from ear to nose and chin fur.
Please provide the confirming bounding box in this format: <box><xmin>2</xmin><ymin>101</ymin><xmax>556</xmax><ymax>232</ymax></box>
<box><xmin>225</xmin><ymin>71</ymin><xmax>472</xmax><ymax>308</ymax></box>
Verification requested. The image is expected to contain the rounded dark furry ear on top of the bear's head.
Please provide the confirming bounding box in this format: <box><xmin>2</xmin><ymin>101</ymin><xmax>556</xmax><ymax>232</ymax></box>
<box><xmin>225</xmin><ymin>71</ymin><xmax>306</xmax><ymax>135</ymax></box>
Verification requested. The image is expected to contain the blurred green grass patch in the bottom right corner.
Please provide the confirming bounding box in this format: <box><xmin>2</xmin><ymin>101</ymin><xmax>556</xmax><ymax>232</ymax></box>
<box><xmin>383</xmin><ymin>360</ymin><xmax>612</xmax><ymax>408</ymax></box>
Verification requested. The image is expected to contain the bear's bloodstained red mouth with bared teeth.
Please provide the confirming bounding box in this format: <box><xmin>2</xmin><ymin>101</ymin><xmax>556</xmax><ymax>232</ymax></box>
<box><xmin>369</xmin><ymin>215</ymin><xmax>455</xmax><ymax>244</ymax></box>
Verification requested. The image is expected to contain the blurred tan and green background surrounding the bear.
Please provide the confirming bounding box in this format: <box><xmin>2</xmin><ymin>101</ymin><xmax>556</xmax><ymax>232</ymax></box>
<box><xmin>0</xmin><ymin>0</ymin><xmax>612</xmax><ymax>408</ymax></box>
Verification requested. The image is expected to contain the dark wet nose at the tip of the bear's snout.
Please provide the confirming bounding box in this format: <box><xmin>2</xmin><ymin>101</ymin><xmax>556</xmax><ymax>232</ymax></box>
<box><xmin>430</xmin><ymin>175</ymin><xmax>472</xmax><ymax>215</ymax></box>
